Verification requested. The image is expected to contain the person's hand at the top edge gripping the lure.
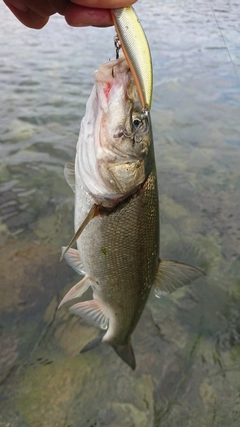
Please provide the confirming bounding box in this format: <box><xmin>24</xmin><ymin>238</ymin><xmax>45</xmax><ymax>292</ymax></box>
<box><xmin>4</xmin><ymin>0</ymin><xmax>137</xmax><ymax>29</ymax></box>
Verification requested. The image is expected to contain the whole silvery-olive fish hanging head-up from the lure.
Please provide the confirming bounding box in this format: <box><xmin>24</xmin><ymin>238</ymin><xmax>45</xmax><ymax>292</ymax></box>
<box><xmin>59</xmin><ymin>55</ymin><xmax>204</xmax><ymax>370</ymax></box>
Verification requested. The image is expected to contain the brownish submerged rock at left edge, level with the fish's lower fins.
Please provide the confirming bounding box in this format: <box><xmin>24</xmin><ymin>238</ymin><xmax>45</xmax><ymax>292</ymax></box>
<box><xmin>0</xmin><ymin>244</ymin><xmax>74</xmax><ymax>317</ymax></box>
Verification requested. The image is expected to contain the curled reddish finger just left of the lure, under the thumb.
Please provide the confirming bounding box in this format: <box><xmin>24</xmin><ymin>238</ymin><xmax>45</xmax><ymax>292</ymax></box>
<box><xmin>65</xmin><ymin>3</ymin><xmax>113</xmax><ymax>27</ymax></box>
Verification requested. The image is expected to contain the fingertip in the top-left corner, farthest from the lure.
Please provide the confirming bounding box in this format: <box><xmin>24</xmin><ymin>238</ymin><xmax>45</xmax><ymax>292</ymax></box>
<box><xmin>4</xmin><ymin>0</ymin><xmax>49</xmax><ymax>30</ymax></box>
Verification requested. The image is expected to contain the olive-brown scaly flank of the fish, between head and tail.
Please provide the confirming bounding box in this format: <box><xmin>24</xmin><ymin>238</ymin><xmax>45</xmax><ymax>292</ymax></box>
<box><xmin>78</xmin><ymin>173</ymin><xmax>159</xmax><ymax>331</ymax></box>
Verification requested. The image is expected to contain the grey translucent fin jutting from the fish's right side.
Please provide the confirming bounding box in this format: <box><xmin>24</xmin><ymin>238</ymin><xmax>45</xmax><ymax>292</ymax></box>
<box><xmin>154</xmin><ymin>260</ymin><xmax>205</xmax><ymax>298</ymax></box>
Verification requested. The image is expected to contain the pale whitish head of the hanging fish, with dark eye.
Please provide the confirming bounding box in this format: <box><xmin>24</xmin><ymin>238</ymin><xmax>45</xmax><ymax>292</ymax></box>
<box><xmin>76</xmin><ymin>56</ymin><xmax>152</xmax><ymax>206</ymax></box>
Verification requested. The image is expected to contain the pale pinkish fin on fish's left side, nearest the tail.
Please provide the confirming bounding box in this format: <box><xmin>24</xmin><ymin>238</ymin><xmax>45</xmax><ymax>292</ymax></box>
<box><xmin>69</xmin><ymin>299</ymin><xmax>108</xmax><ymax>329</ymax></box>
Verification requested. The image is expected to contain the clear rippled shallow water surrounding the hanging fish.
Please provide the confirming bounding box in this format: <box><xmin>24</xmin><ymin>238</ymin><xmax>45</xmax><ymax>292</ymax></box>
<box><xmin>0</xmin><ymin>0</ymin><xmax>240</xmax><ymax>427</ymax></box>
